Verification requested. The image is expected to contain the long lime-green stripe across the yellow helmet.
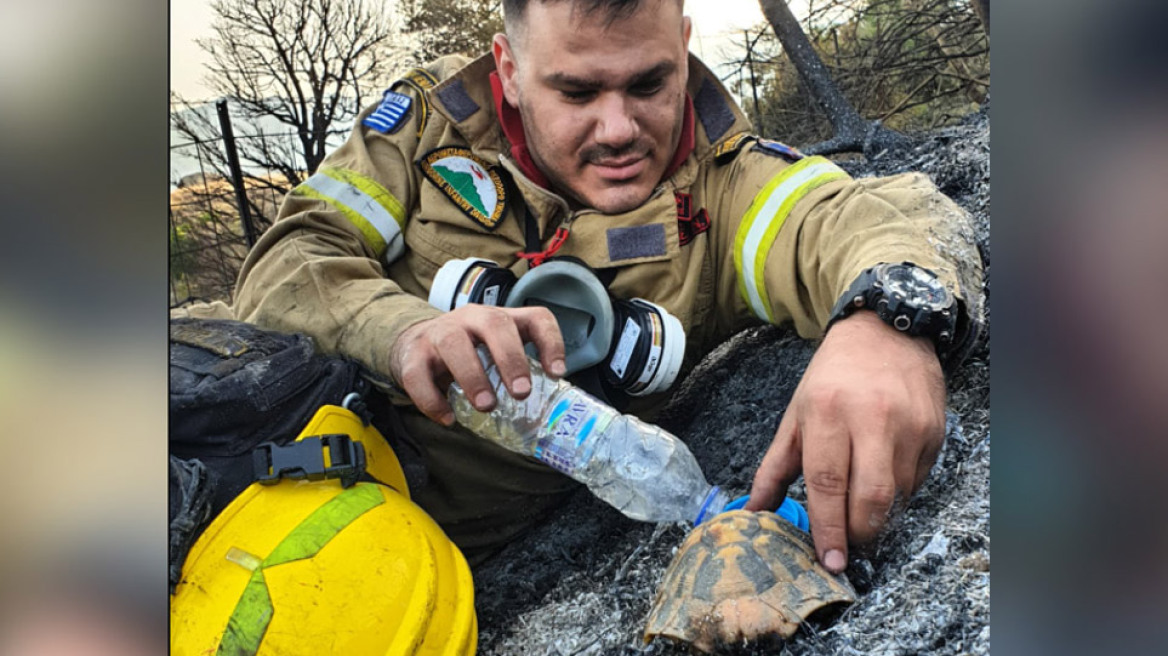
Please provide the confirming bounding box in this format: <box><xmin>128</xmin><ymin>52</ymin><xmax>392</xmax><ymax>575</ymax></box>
<box><xmin>217</xmin><ymin>483</ymin><xmax>385</xmax><ymax>654</ymax></box>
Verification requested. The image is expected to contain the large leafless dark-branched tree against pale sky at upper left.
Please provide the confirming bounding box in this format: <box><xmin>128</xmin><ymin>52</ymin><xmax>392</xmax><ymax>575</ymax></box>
<box><xmin>171</xmin><ymin>0</ymin><xmax>401</xmax><ymax>201</ymax></box>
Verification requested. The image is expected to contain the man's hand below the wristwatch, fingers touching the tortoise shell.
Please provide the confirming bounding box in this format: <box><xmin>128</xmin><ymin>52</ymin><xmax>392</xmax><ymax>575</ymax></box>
<box><xmin>746</xmin><ymin>310</ymin><xmax>945</xmax><ymax>573</ymax></box>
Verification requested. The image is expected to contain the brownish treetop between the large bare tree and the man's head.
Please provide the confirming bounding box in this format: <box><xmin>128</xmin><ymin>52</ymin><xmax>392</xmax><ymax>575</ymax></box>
<box><xmin>399</xmin><ymin>0</ymin><xmax>503</xmax><ymax>64</ymax></box>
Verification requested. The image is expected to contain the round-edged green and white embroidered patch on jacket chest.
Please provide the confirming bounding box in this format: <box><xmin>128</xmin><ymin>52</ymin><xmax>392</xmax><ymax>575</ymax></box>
<box><xmin>418</xmin><ymin>146</ymin><xmax>507</xmax><ymax>230</ymax></box>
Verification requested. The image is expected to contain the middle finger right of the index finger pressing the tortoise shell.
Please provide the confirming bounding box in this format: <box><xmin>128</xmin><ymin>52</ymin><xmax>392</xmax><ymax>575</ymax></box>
<box><xmin>848</xmin><ymin>433</ymin><xmax>892</xmax><ymax>543</ymax></box>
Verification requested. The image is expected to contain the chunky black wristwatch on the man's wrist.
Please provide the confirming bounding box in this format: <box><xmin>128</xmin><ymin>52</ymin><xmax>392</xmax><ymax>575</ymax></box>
<box><xmin>827</xmin><ymin>261</ymin><xmax>961</xmax><ymax>363</ymax></box>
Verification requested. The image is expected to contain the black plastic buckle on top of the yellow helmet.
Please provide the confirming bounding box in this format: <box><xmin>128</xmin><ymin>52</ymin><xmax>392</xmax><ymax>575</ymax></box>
<box><xmin>252</xmin><ymin>433</ymin><xmax>366</xmax><ymax>488</ymax></box>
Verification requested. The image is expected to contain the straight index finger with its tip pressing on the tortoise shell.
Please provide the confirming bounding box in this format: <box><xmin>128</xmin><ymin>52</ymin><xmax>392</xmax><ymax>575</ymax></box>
<box><xmin>801</xmin><ymin>413</ymin><xmax>851</xmax><ymax>574</ymax></box>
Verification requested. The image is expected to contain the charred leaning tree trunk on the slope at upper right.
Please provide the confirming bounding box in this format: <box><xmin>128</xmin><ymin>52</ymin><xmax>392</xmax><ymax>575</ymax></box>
<box><xmin>759</xmin><ymin>0</ymin><xmax>904</xmax><ymax>155</ymax></box>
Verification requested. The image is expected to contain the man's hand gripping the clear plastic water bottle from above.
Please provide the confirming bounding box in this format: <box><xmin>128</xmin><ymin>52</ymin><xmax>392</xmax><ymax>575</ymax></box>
<box><xmin>389</xmin><ymin>303</ymin><xmax>565</xmax><ymax>426</ymax></box>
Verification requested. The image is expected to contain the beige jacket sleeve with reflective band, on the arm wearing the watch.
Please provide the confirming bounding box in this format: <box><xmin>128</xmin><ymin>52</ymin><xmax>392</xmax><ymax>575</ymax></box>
<box><xmin>712</xmin><ymin>148</ymin><xmax>982</xmax><ymax>347</ymax></box>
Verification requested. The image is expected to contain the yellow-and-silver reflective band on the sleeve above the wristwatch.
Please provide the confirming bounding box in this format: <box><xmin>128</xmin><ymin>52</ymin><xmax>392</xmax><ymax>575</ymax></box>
<box><xmin>734</xmin><ymin>156</ymin><xmax>848</xmax><ymax>323</ymax></box>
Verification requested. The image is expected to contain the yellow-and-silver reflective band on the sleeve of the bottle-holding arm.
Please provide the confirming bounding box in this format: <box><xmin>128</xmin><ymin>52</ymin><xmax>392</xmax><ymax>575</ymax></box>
<box><xmin>292</xmin><ymin>168</ymin><xmax>405</xmax><ymax>261</ymax></box>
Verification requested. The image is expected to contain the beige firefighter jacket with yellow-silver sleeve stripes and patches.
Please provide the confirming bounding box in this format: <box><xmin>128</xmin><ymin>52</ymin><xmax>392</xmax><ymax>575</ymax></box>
<box><xmin>235</xmin><ymin>55</ymin><xmax>981</xmax><ymax>405</ymax></box>
